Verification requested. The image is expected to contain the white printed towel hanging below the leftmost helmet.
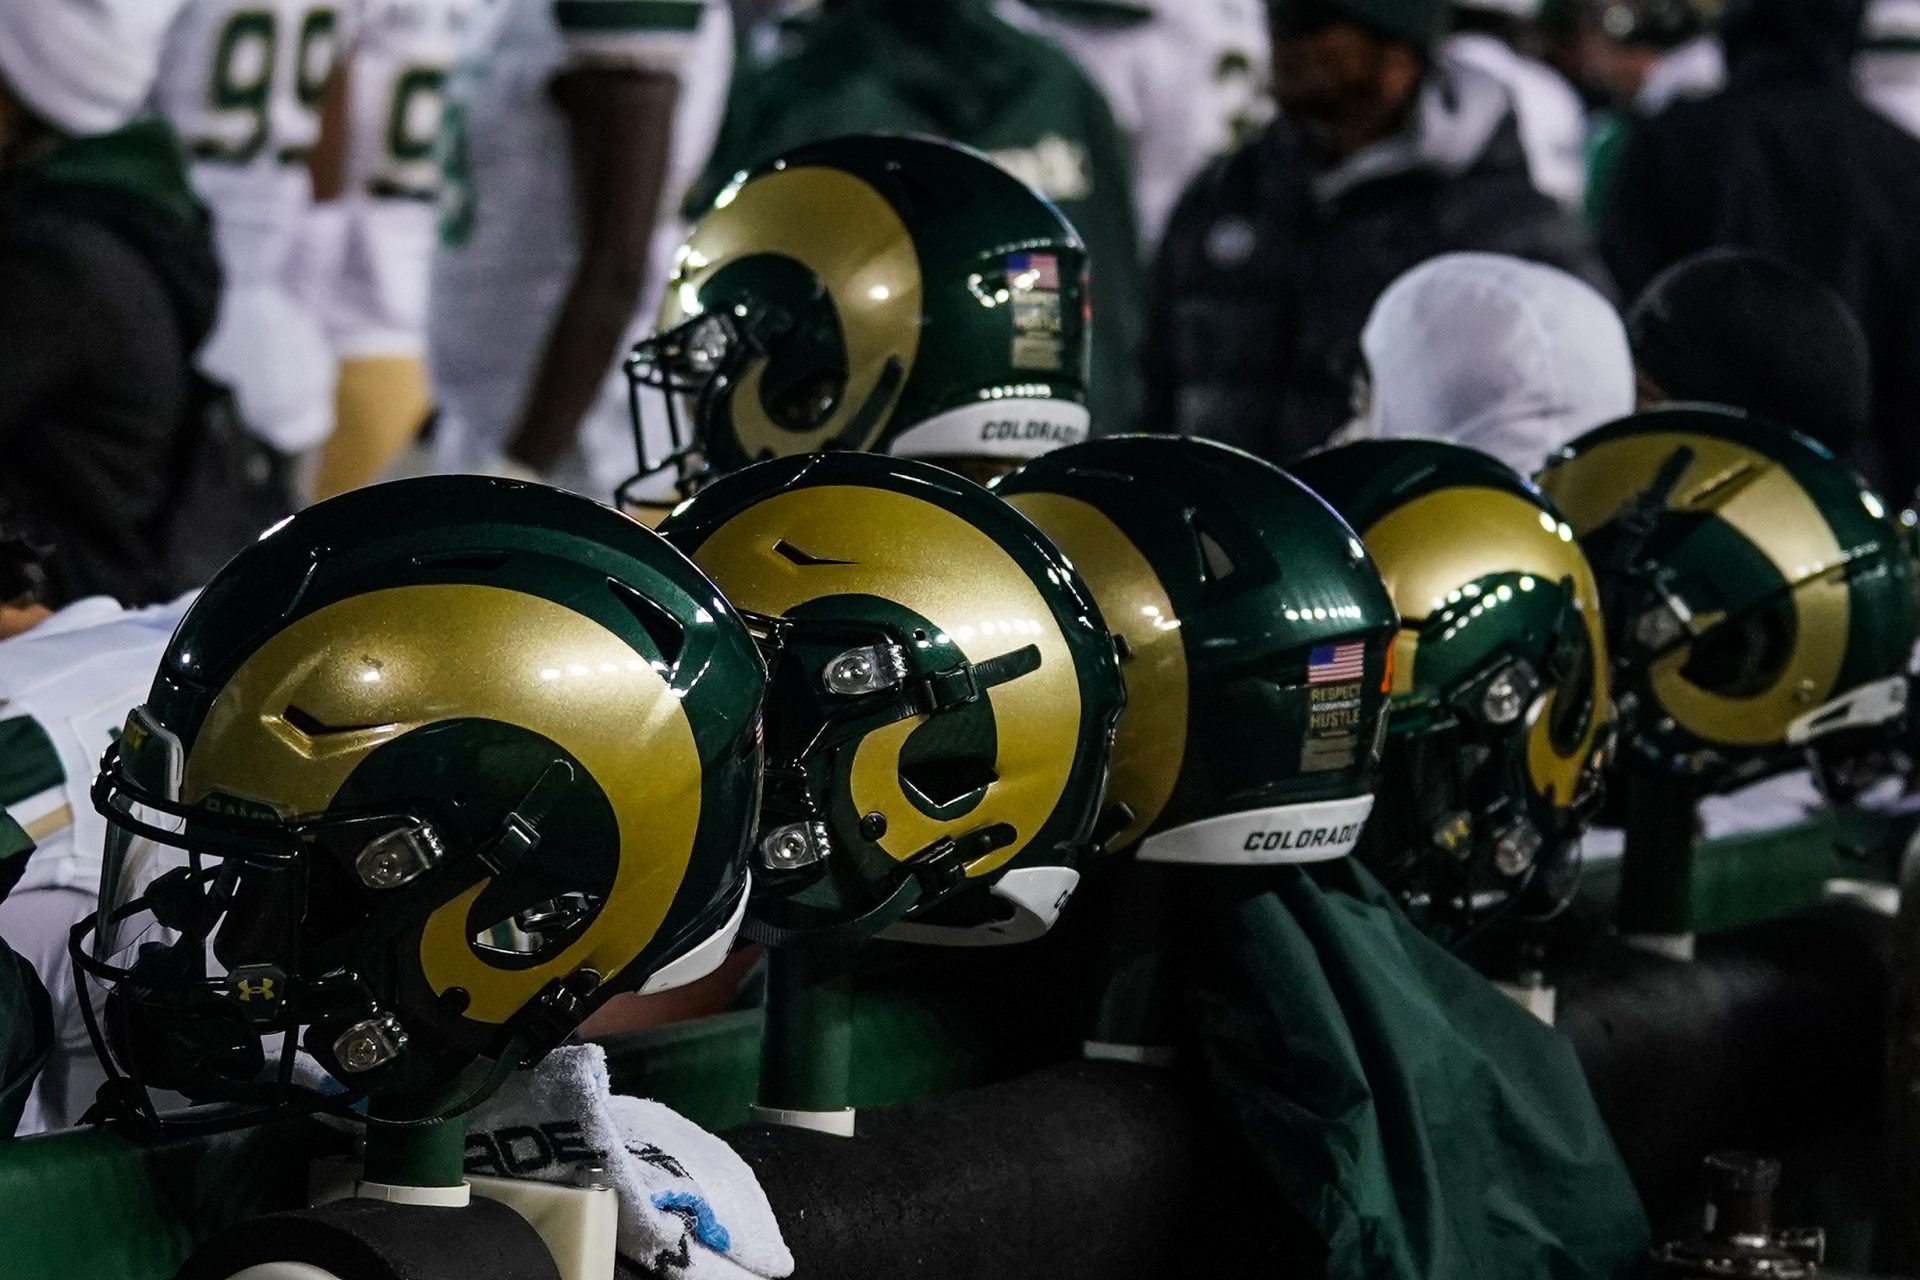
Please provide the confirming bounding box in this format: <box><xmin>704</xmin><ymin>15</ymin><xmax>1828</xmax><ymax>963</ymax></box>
<box><xmin>467</xmin><ymin>1044</ymin><xmax>793</xmax><ymax>1280</ymax></box>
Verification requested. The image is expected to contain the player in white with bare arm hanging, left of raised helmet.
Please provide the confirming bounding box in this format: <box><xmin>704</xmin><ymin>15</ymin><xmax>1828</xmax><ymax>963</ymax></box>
<box><xmin>428</xmin><ymin>0</ymin><xmax>733</xmax><ymax>501</ymax></box>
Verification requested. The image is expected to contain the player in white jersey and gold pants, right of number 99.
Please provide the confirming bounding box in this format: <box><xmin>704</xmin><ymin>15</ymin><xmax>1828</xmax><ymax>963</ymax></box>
<box><xmin>313</xmin><ymin>0</ymin><xmax>478</xmax><ymax>501</ymax></box>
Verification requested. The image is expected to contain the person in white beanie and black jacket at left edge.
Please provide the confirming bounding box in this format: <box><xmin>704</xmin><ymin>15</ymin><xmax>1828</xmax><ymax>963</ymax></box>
<box><xmin>0</xmin><ymin>0</ymin><xmax>221</xmax><ymax>606</ymax></box>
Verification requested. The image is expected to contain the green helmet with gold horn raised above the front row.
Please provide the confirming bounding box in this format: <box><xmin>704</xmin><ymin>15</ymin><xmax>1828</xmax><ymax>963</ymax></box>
<box><xmin>620</xmin><ymin>134</ymin><xmax>1089</xmax><ymax>505</ymax></box>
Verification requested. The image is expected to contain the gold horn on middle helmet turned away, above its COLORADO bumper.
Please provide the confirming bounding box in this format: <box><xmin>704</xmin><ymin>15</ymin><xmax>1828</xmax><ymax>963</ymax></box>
<box><xmin>1008</xmin><ymin>493</ymin><xmax>1187</xmax><ymax>848</ymax></box>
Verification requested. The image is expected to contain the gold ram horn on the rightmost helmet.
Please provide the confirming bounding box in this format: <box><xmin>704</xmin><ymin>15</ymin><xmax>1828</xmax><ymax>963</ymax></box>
<box><xmin>1540</xmin><ymin>432</ymin><xmax>1851</xmax><ymax>747</ymax></box>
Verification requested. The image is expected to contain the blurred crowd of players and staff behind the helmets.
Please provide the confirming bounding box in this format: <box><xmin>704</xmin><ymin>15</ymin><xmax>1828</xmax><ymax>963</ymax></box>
<box><xmin>0</xmin><ymin>0</ymin><xmax>1920</xmax><ymax>606</ymax></box>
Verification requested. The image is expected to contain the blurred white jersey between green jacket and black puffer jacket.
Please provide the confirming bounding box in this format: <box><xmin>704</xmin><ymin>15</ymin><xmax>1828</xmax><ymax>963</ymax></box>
<box><xmin>998</xmin><ymin>0</ymin><xmax>1271</xmax><ymax>257</ymax></box>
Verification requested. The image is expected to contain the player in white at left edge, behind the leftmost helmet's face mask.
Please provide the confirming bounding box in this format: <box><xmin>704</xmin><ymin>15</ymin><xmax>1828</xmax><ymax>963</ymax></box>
<box><xmin>0</xmin><ymin>595</ymin><xmax>192</xmax><ymax>1134</ymax></box>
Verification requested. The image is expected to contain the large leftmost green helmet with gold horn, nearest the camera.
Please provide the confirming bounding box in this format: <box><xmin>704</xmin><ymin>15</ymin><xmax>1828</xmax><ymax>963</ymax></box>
<box><xmin>73</xmin><ymin>476</ymin><xmax>766</xmax><ymax>1119</ymax></box>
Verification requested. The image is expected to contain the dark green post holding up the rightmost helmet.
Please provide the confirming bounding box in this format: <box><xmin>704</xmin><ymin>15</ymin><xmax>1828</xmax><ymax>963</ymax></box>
<box><xmin>1615</xmin><ymin>771</ymin><xmax>1699</xmax><ymax>960</ymax></box>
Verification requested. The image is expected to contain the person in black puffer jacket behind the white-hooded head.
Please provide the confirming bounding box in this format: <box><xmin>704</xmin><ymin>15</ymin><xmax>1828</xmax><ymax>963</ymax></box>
<box><xmin>1144</xmin><ymin>0</ymin><xmax>1609</xmax><ymax>462</ymax></box>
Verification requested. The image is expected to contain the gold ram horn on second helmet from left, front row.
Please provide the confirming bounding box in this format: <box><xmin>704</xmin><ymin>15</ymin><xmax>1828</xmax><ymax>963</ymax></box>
<box><xmin>693</xmin><ymin>486</ymin><xmax>1081</xmax><ymax>875</ymax></box>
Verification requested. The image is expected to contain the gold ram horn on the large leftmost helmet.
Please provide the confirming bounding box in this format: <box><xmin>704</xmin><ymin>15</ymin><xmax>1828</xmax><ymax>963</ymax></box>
<box><xmin>182</xmin><ymin>583</ymin><xmax>701</xmax><ymax>1023</ymax></box>
